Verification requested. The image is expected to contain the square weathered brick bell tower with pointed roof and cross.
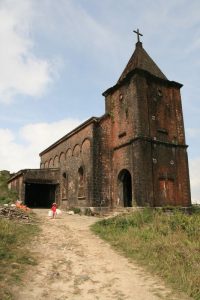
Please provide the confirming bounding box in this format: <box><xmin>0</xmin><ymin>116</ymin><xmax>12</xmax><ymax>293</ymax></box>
<box><xmin>103</xmin><ymin>29</ymin><xmax>191</xmax><ymax>206</ymax></box>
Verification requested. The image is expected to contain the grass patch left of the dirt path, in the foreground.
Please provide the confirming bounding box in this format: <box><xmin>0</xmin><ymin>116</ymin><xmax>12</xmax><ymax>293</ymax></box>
<box><xmin>0</xmin><ymin>219</ymin><xmax>38</xmax><ymax>300</ymax></box>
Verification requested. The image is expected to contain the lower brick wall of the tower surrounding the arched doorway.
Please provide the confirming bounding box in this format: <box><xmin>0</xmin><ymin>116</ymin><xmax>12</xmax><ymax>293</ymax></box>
<box><xmin>113</xmin><ymin>140</ymin><xmax>153</xmax><ymax>206</ymax></box>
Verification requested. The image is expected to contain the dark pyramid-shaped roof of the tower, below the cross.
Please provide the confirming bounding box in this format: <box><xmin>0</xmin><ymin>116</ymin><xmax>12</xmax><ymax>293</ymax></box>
<box><xmin>117</xmin><ymin>42</ymin><xmax>167</xmax><ymax>83</ymax></box>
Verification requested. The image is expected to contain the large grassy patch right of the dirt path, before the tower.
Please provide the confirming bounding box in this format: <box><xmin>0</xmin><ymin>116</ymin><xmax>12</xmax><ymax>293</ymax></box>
<box><xmin>92</xmin><ymin>206</ymin><xmax>200</xmax><ymax>300</ymax></box>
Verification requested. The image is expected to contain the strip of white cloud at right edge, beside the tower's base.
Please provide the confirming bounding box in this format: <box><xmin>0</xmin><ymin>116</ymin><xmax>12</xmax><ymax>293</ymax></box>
<box><xmin>189</xmin><ymin>158</ymin><xmax>200</xmax><ymax>203</ymax></box>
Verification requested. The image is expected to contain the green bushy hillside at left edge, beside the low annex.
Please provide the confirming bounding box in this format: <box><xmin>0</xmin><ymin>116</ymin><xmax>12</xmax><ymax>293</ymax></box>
<box><xmin>0</xmin><ymin>170</ymin><xmax>17</xmax><ymax>204</ymax></box>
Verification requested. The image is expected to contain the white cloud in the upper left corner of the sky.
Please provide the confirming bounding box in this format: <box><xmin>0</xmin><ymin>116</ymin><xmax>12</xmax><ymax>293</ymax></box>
<box><xmin>0</xmin><ymin>0</ymin><xmax>52</xmax><ymax>103</ymax></box>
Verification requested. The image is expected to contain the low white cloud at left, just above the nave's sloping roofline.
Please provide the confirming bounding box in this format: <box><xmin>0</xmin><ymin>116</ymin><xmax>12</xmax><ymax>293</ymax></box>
<box><xmin>0</xmin><ymin>119</ymin><xmax>81</xmax><ymax>172</ymax></box>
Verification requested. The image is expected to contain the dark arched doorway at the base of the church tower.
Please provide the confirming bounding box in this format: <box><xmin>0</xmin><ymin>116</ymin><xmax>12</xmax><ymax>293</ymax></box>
<box><xmin>118</xmin><ymin>169</ymin><xmax>132</xmax><ymax>207</ymax></box>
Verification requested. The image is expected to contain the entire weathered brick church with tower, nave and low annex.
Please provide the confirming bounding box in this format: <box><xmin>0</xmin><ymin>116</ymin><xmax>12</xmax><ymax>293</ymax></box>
<box><xmin>8</xmin><ymin>30</ymin><xmax>191</xmax><ymax>209</ymax></box>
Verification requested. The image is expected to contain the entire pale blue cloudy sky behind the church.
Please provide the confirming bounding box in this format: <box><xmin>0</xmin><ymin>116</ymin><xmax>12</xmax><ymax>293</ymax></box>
<box><xmin>0</xmin><ymin>0</ymin><xmax>200</xmax><ymax>202</ymax></box>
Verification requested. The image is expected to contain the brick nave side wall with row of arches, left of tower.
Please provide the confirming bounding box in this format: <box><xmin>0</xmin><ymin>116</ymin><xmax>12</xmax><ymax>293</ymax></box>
<box><xmin>41</xmin><ymin>123</ymin><xmax>94</xmax><ymax>207</ymax></box>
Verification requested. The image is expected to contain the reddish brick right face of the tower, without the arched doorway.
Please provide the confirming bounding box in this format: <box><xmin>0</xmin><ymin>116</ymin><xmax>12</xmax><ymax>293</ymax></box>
<box><xmin>145</xmin><ymin>78</ymin><xmax>191</xmax><ymax>206</ymax></box>
